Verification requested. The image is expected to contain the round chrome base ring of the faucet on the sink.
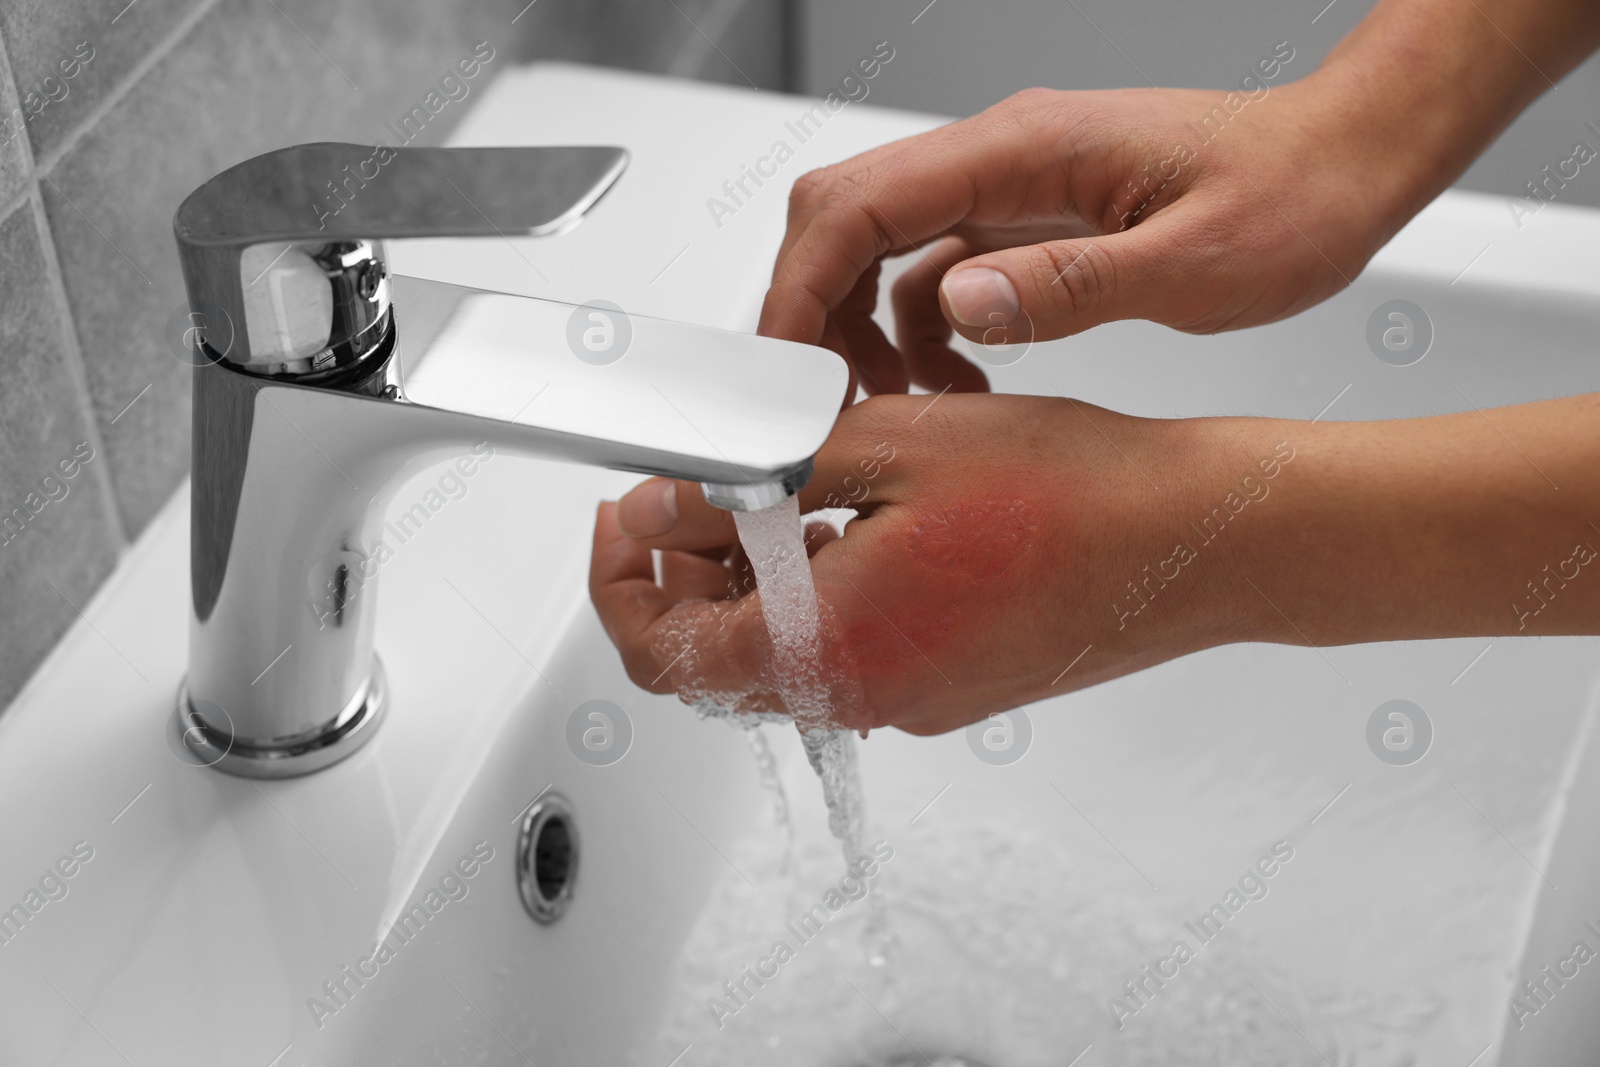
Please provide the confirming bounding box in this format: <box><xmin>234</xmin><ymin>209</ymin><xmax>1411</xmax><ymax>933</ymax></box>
<box><xmin>166</xmin><ymin>656</ymin><xmax>389</xmax><ymax>777</ymax></box>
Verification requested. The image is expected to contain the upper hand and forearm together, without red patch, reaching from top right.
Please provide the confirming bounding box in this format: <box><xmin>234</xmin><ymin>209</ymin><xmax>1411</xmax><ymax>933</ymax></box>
<box><xmin>760</xmin><ymin>0</ymin><xmax>1600</xmax><ymax>394</ymax></box>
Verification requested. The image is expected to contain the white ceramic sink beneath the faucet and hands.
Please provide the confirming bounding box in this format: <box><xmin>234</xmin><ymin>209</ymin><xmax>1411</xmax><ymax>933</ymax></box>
<box><xmin>0</xmin><ymin>66</ymin><xmax>1600</xmax><ymax>1067</ymax></box>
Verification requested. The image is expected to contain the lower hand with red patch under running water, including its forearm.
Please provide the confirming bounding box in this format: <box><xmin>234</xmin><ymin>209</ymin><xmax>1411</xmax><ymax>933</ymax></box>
<box><xmin>589</xmin><ymin>394</ymin><xmax>1600</xmax><ymax>734</ymax></box>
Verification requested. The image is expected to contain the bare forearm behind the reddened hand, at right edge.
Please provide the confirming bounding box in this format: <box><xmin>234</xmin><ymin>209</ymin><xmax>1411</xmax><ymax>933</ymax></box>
<box><xmin>1214</xmin><ymin>394</ymin><xmax>1600</xmax><ymax>645</ymax></box>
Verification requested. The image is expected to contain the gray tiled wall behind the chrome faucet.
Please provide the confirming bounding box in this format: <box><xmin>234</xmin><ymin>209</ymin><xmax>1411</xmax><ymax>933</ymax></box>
<box><xmin>0</xmin><ymin>0</ymin><xmax>787</xmax><ymax>707</ymax></box>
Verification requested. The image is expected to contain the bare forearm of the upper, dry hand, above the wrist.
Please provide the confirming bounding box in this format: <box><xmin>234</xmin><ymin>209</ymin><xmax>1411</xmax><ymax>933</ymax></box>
<box><xmin>1298</xmin><ymin>0</ymin><xmax>1600</xmax><ymax>243</ymax></box>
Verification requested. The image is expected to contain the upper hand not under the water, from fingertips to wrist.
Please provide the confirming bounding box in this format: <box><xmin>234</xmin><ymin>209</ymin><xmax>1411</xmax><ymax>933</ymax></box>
<box><xmin>760</xmin><ymin>75</ymin><xmax>1410</xmax><ymax>394</ymax></box>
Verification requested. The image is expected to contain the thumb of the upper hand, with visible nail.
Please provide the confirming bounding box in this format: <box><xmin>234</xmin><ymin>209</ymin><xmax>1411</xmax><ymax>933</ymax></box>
<box><xmin>939</xmin><ymin>219</ymin><xmax>1190</xmax><ymax>344</ymax></box>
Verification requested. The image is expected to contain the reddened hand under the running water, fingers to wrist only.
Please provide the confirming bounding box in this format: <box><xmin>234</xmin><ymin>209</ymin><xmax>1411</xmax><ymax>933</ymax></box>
<box><xmin>590</xmin><ymin>395</ymin><xmax>1260</xmax><ymax>733</ymax></box>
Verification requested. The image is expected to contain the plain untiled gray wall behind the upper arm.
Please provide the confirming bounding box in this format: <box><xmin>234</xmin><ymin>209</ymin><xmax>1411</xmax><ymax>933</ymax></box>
<box><xmin>798</xmin><ymin>0</ymin><xmax>1600</xmax><ymax>206</ymax></box>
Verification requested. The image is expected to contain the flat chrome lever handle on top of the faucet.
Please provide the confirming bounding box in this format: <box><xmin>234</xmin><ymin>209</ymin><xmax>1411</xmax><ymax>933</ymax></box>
<box><xmin>173</xmin><ymin>142</ymin><xmax>627</xmax><ymax>374</ymax></box>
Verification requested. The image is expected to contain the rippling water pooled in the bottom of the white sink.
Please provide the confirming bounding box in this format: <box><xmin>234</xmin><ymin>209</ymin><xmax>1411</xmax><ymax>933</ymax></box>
<box><xmin>652</xmin><ymin>795</ymin><xmax>1452</xmax><ymax>1067</ymax></box>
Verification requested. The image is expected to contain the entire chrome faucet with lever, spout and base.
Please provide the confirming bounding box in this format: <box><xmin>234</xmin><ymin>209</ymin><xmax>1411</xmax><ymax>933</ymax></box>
<box><xmin>171</xmin><ymin>144</ymin><xmax>848</xmax><ymax>777</ymax></box>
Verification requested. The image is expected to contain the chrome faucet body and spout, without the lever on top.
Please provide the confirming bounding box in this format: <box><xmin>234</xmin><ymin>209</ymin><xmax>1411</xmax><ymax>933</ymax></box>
<box><xmin>173</xmin><ymin>149</ymin><xmax>850</xmax><ymax>777</ymax></box>
